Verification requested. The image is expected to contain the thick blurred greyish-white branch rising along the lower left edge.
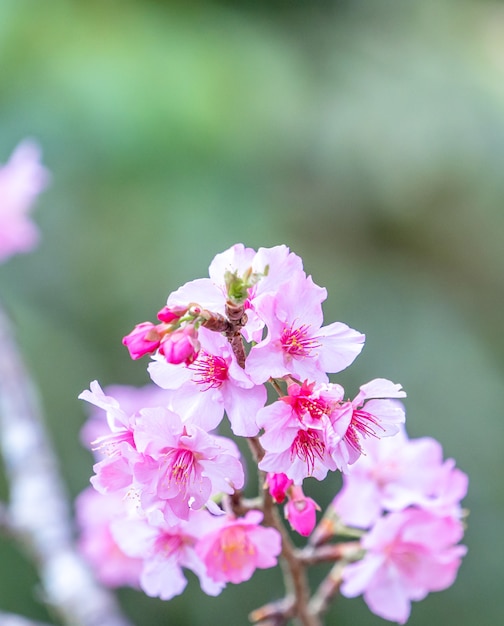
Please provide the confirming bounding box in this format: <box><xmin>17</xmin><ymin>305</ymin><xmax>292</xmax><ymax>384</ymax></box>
<box><xmin>0</xmin><ymin>308</ymin><xmax>134</xmax><ymax>626</ymax></box>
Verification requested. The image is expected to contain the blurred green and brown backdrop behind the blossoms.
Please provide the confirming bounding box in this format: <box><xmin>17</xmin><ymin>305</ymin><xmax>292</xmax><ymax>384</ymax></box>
<box><xmin>0</xmin><ymin>0</ymin><xmax>504</xmax><ymax>626</ymax></box>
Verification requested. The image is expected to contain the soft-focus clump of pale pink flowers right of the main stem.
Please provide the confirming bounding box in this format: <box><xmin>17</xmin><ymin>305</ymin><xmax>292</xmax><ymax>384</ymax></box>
<box><xmin>332</xmin><ymin>422</ymin><xmax>467</xmax><ymax>624</ymax></box>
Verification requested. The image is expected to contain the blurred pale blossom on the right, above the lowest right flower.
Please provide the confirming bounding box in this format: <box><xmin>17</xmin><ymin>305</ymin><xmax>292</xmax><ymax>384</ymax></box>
<box><xmin>333</xmin><ymin>428</ymin><xmax>467</xmax><ymax>528</ymax></box>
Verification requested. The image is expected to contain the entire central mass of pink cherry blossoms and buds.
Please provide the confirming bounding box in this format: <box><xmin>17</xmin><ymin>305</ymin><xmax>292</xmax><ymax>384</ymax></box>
<box><xmin>78</xmin><ymin>244</ymin><xmax>466</xmax><ymax>622</ymax></box>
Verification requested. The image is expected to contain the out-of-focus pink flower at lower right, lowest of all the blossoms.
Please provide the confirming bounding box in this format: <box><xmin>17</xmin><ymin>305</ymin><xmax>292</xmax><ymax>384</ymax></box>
<box><xmin>341</xmin><ymin>509</ymin><xmax>466</xmax><ymax>624</ymax></box>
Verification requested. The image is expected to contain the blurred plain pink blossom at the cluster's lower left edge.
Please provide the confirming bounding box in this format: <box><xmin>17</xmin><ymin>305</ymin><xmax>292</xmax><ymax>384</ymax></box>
<box><xmin>75</xmin><ymin>487</ymin><xmax>142</xmax><ymax>587</ymax></box>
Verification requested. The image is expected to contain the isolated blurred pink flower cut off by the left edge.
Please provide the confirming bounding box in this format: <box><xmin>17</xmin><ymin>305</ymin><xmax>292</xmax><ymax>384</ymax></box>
<box><xmin>0</xmin><ymin>140</ymin><xmax>49</xmax><ymax>263</ymax></box>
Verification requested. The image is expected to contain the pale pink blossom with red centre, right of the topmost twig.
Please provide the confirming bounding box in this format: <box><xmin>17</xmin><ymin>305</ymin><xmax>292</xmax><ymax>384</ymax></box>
<box><xmin>245</xmin><ymin>274</ymin><xmax>364</xmax><ymax>384</ymax></box>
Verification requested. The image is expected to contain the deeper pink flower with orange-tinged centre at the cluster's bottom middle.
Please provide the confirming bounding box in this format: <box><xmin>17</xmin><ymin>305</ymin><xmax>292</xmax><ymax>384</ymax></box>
<box><xmin>196</xmin><ymin>511</ymin><xmax>282</xmax><ymax>583</ymax></box>
